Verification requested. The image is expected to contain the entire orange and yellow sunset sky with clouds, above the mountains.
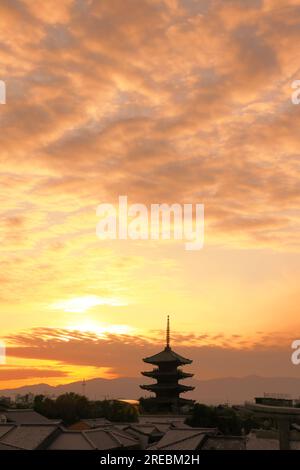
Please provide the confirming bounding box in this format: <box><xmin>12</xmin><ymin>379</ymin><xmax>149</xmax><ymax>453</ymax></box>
<box><xmin>0</xmin><ymin>0</ymin><xmax>300</xmax><ymax>389</ymax></box>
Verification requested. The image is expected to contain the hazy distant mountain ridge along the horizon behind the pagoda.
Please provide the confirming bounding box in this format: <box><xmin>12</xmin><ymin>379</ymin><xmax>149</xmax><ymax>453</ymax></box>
<box><xmin>0</xmin><ymin>375</ymin><xmax>300</xmax><ymax>404</ymax></box>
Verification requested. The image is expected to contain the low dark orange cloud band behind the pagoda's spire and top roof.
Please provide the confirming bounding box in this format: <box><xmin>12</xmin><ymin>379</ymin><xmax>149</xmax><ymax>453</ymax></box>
<box><xmin>2</xmin><ymin>328</ymin><xmax>297</xmax><ymax>378</ymax></box>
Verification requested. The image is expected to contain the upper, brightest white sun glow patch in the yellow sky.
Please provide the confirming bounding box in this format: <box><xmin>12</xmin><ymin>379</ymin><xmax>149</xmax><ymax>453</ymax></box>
<box><xmin>50</xmin><ymin>295</ymin><xmax>127</xmax><ymax>313</ymax></box>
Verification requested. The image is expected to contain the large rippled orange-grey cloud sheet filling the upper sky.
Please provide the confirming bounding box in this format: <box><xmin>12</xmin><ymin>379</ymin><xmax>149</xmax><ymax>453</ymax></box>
<box><xmin>1</xmin><ymin>0</ymin><xmax>300</xmax><ymax>249</ymax></box>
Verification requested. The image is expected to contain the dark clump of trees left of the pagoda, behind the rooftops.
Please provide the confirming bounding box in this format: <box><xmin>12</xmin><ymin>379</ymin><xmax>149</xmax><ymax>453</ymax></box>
<box><xmin>33</xmin><ymin>393</ymin><xmax>138</xmax><ymax>425</ymax></box>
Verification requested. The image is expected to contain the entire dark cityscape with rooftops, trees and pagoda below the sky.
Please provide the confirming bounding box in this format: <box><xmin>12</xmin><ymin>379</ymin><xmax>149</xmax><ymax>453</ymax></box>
<box><xmin>0</xmin><ymin>316</ymin><xmax>300</xmax><ymax>451</ymax></box>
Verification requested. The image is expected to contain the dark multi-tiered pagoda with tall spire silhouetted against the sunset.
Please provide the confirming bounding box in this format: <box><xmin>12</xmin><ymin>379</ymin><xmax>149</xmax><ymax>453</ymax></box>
<box><xmin>140</xmin><ymin>316</ymin><xmax>195</xmax><ymax>412</ymax></box>
